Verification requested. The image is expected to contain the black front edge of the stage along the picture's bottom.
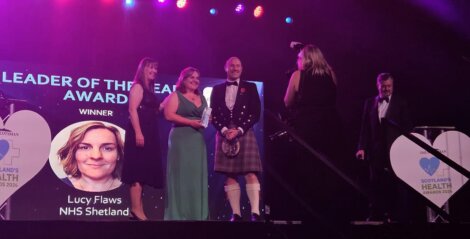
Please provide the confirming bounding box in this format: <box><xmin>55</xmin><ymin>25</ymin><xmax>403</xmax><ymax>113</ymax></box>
<box><xmin>0</xmin><ymin>221</ymin><xmax>469</xmax><ymax>239</ymax></box>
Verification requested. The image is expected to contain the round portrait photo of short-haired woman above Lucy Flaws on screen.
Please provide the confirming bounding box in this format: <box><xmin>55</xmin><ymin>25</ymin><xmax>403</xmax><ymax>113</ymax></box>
<box><xmin>51</xmin><ymin>121</ymin><xmax>124</xmax><ymax>192</ymax></box>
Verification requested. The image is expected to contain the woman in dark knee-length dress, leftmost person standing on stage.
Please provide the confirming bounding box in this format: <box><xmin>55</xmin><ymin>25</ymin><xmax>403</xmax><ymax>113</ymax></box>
<box><xmin>122</xmin><ymin>58</ymin><xmax>163</xmax><ymax>221</ymax></box>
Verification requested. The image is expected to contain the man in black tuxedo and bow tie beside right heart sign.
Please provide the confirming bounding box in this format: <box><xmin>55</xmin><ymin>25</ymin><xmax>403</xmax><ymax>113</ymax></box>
<box><xmin>356</xmin><ymin>73</ymin><xmax>412</xmax><ymax>221</ymax></box>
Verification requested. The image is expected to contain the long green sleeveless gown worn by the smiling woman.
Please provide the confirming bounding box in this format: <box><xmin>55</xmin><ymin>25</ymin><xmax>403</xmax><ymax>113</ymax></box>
<box><xmin>165</xmin><ymin>91</ymin><xmax>209</xmax><ymax>220</ymax></box>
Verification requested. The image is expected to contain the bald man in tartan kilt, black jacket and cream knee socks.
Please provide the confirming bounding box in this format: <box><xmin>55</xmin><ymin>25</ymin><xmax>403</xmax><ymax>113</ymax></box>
<box><xmin>210</xmin><ymin>57</ymin><xmax>262</xmax><ymax>221</ymax></box>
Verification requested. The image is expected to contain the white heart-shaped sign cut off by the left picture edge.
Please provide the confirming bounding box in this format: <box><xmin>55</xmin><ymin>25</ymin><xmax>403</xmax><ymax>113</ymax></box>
<box><xmin>0</xmin><ymin>110</ymin><xmax>51</xmax><ymax>204</ymax></box>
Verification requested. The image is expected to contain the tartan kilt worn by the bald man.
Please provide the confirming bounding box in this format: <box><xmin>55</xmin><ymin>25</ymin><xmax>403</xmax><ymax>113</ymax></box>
<box><xmin>214</xmin><ymin>129</ymin><xmax>263</xmax><ymax>174</ymax></box>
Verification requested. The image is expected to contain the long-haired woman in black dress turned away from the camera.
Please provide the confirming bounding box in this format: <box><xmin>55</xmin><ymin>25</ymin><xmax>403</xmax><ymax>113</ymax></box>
<box><xmin>284</xmin><ymin>45</ymin><xmax>343</xmax><ymax>220</ymax></box>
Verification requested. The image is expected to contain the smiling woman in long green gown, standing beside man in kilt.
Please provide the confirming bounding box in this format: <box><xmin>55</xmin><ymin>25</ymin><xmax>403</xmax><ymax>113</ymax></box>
<box><xmin>164</xmin><ymin>67</ymin><xmax>209</xmax><ymax>220</ymax></box>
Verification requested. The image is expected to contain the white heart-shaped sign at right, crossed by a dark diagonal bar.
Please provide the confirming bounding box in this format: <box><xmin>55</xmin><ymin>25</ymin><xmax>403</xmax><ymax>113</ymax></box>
<box><xmin>390</xmin><ymin>131</ymin><xmax>470</xmax><ymax>207</ymax></box>
